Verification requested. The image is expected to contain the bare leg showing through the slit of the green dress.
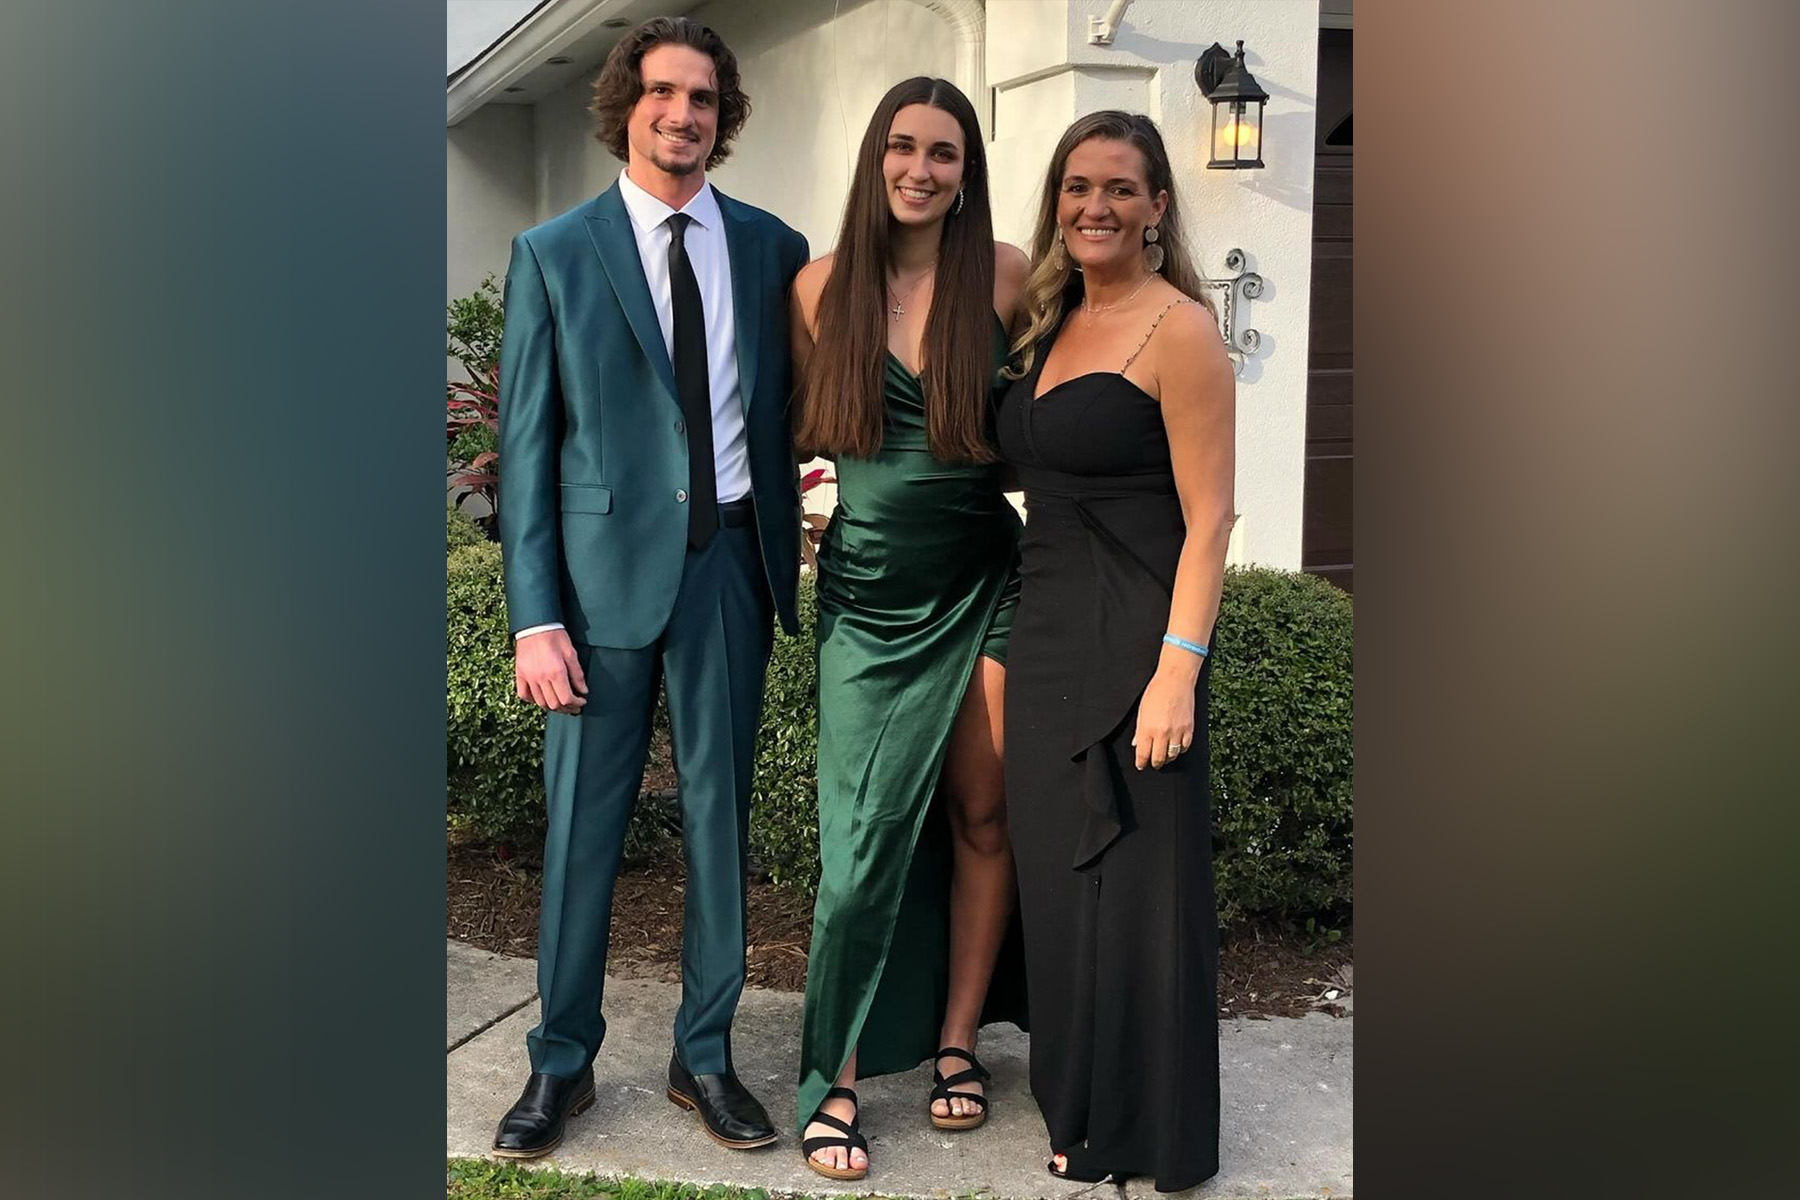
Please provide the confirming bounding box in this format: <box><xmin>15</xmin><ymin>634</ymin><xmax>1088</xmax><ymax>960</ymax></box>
<box><xmin>931</xmin><ymin>655</ymin><xmax>1015</xmax><ymax>1117</ymax></box>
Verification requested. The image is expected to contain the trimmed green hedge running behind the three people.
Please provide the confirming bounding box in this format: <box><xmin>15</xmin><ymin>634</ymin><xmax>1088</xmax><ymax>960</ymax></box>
<box><xmin>448</xmin><ymin>557</ymin><xmax>1352</xmax><ymax>925</ymax></box>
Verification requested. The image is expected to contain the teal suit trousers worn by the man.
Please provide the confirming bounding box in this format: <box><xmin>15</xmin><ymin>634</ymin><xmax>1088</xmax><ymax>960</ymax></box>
<box><xmin>527</xmin><ymin>525</ymin><xmax>774</xmax><ymax>1076</ymax></box>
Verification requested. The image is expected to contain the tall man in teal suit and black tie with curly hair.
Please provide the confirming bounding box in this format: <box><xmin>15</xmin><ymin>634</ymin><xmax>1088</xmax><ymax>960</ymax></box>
<box><xmin>493</xmin><ymin>18</ymin><xmax>806</xmax><ymax>1159</ymax></box>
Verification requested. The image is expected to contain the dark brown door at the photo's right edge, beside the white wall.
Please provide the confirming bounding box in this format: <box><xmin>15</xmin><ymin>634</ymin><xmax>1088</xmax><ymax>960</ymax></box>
<box><xmin>1300</xmin><ymin>29</ymin><xmax>1355</xmax><ymax>592</ymax></box>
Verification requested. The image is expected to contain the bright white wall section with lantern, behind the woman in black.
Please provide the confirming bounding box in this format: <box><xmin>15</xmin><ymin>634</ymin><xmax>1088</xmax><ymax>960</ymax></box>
<box><xmin>986</xmin><ymin>0</ymin><xmax>1318</xmax><ymax>570</ymax></box>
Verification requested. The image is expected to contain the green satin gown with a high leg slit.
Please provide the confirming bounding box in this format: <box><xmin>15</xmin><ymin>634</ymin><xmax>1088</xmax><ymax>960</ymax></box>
<box><xmin>797</xmin><ymin>327</ymin><xmax>1024</xmax><ymax>1130</ymax></box>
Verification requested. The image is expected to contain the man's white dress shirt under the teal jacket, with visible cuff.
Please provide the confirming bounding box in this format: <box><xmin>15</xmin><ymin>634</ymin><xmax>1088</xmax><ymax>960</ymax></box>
<box><xmin>513</xmin><ymin>171</ymin><xmax>751</xmax><ymax>639</ymax></box>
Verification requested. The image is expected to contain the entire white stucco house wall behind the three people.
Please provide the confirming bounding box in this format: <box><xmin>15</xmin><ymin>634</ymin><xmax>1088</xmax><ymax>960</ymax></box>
<box><xmin>450</xmin><ymin>0</ymin><xmax>1319</xmax><ymax>569</ymax></box>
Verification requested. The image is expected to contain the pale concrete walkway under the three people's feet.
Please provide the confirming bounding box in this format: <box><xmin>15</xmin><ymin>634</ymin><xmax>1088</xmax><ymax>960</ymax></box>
<box><xmin>445</xmin><ymin>941</ymin><xmax>1354</xmax><ymax>1200</ymax></box>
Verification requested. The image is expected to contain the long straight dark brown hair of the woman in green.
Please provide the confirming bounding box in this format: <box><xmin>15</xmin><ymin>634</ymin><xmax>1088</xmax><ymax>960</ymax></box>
<box><xmin>794</xmin><ymin>76</ymin><xmax>995</xmax><ymax>462</ymax></box>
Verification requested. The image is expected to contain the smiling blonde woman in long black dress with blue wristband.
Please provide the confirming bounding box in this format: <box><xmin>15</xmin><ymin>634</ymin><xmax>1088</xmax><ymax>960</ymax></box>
<box><xmin>997</xmin><ymin>112</ymin><xmax>1233</xmax><ymax>1191</ymax></box>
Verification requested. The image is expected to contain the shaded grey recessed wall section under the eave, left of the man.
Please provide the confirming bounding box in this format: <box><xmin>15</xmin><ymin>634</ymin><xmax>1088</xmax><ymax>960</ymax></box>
<box><xmin>445</xmin><ymin>104</ymin><xmax>536</xmax><ymax>299</ymax></box>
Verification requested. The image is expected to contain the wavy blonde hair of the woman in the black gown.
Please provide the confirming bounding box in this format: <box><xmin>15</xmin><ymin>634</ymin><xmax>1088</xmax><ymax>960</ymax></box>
<box><xmin>1003</xmin><ymin>108</ymin><xmax>1219</xmax><ymax>380</ymax></box>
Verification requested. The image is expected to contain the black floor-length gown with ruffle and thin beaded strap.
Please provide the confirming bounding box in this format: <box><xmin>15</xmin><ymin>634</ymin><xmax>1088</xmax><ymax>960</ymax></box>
<box><xmin>997</xmin><ymin>318</ymin><xmax>1219</xmax><ymax>1191</ymax></box>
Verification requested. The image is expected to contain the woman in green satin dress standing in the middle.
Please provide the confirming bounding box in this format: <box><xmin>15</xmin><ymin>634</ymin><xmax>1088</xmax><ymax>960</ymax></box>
<box><xmin>792</xmin><ymin>77</ymin><xmax>1028</xmax><ymax>1178</ymax></box>
